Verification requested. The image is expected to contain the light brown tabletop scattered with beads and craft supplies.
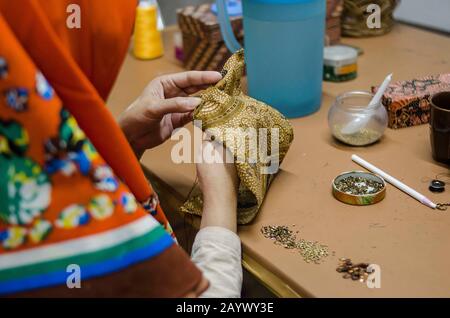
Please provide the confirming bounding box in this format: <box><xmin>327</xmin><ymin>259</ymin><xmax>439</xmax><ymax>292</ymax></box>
<box><xmin>108</xmin><ymin>25</ymin><xmax>450</xmax><ymax>297</ymax></box>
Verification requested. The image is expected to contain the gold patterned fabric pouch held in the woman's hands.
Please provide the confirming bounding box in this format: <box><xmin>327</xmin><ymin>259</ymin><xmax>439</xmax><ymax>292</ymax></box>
<box><xmin>180</xmin><ymin>50</ymin><xmax>294</xmax><ymax>224</ymax></box>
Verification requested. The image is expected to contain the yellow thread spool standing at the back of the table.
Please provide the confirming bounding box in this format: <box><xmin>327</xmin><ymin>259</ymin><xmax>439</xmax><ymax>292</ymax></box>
<box><xmin>133</xmin><ymin>0</ymin><xmax>164</xmax><ymax>60</ymax></box>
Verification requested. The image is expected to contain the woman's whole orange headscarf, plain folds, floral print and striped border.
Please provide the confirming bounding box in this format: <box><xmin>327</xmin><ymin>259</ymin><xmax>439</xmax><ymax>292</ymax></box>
<box><xmin>0</xmin><ymin>0</ymin><xmax>201</xmax><ymax>297</ymax></box>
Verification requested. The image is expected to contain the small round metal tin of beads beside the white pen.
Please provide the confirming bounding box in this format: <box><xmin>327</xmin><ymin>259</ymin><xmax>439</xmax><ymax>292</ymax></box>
<box><xmin>331</xmin><ymin>171</ymin><xmax>386</xmax><ymax>205</ymax></box>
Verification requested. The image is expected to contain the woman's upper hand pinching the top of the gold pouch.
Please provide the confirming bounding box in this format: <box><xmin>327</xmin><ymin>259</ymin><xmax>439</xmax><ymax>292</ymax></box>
<box><xmin>119</xmin><ymin>71</ymin><xmax>222</xmax><ymax>158</ymax></box>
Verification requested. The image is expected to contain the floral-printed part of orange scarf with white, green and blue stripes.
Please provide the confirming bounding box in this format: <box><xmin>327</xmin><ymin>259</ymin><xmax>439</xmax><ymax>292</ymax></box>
<box><xmin>0</xmin><ymin>1</ymin><xmax>201</xmax><ymax>296</ymax></box>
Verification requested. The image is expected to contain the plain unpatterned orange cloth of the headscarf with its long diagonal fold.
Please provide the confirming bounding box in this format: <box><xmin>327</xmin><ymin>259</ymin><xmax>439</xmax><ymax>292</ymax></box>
<box><xmin>0</xmin><ymin>0</ymin><xmax>167</xmax><ymax>223</ymax></box>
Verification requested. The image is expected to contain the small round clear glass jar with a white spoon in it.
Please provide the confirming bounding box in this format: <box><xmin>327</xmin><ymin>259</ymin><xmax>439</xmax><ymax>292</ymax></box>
<box><xmin>328</xmin><ymin>91</ymin><xmax>388</xmax><ymax>146</ymax></box>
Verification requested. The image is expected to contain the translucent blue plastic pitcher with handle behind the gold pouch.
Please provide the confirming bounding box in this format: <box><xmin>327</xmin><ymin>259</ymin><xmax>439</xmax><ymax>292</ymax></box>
<box><xmin>216</xmin><ymin>0</ymin><xmax>326</xmax><ymax>118</ymax></box>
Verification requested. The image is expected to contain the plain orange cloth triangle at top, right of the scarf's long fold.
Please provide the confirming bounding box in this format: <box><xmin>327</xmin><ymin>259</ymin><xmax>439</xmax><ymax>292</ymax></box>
<box><xmin>39</xmin><ymin>0</ymin><xmax>137</xmax><ymax>100</ymax></box>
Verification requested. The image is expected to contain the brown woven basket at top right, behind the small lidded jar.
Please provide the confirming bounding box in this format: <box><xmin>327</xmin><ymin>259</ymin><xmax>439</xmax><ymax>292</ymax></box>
<box><xmin>341</xmin><ymin>0</ymin><xmax>400</xmax><ymax>37</ymax></box>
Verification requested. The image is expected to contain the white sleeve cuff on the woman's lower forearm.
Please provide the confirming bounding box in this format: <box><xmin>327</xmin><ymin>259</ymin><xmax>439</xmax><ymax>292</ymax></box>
<box><xmin>191</xmin><ymin>226</ymin><xmax>242</xmax><ymax>298</ymax></box>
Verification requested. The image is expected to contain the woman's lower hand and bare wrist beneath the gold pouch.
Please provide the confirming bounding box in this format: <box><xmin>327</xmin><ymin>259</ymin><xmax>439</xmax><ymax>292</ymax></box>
<box><xmin>197</xmin><ymin>141</ymin><xmax>239</xmax><ymax>232</ymax></box>
